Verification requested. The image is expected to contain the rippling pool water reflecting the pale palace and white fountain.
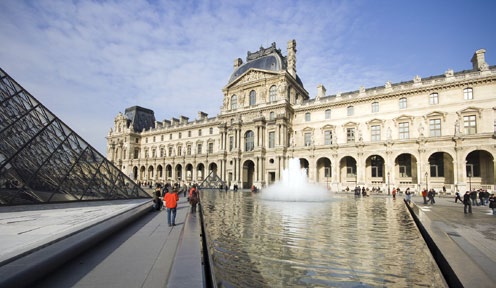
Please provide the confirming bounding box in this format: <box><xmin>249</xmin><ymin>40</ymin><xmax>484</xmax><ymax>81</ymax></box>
<box><xmin>201</xmin><ymin>191</ymin><xmax>446</xmax><ymax>287</ymax></box>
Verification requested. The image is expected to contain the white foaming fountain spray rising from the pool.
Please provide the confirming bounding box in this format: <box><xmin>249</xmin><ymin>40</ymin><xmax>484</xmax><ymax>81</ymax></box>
<box><xmin>260</xmin><ymin>158</ymin><xmax>330</xmax><ymax>202</ymax></box>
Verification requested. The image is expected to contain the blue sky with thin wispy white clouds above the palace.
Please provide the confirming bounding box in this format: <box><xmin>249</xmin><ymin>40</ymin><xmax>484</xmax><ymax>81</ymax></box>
<box><xmin>0</xmin><ymin>0</ymin><xmax>496</xmax><ymax>155</ymax></box>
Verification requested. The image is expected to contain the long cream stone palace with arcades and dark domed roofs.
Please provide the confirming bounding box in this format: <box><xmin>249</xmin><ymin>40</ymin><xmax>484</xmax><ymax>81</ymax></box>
<box><xmin>107</xmin><ymin>40</ymin><xmax>496</xmax><ymax>193</ymax></box>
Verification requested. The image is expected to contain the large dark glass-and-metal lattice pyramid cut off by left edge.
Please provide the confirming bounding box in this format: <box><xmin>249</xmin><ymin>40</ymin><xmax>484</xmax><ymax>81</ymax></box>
<box><xmin>0</xmin><ymin>69</ymin><xmax>150</xmax><ymax>205</ymax></box>
